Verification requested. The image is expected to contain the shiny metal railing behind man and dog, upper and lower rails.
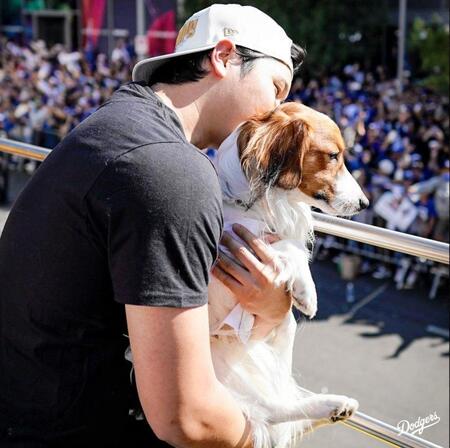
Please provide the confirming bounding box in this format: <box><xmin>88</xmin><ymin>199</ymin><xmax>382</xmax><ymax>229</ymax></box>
<box><xmin>0</xmin><ymin>138</ymin><xmax>449</xmax><ymax>448</ymax></box>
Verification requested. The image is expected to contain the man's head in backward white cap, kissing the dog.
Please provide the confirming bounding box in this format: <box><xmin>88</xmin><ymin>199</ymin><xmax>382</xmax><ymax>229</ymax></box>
<box><xmin>133</xmin><ymin>5</ymin><xmax>305</xmax><ymax>146</ymax></box>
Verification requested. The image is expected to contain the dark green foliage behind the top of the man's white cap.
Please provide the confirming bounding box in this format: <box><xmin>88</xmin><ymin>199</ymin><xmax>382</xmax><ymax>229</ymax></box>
<box><xmin>180</xmin><ymin>0</ymin><xmax>388</xmax><ymax>76</ymax></box>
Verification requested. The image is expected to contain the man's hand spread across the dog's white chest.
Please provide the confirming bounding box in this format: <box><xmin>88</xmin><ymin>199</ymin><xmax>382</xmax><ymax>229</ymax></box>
<box><xmin>213</xmin><ymin>224</ymin><xmax>292</xmax><ymax>337</ymax></box>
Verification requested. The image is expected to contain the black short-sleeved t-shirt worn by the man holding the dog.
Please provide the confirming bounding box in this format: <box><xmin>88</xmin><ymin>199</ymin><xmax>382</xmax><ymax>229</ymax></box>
<box><xmin>0</xmin><ymin>83</ymin><xmax>222</xmax><ymax>447</ymax></box>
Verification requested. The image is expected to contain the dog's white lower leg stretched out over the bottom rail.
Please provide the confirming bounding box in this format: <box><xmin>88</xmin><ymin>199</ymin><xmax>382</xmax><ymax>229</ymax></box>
<box><xmin>266</xmin><ymin>394</ymin><xmax>359</xmax><ymax>425</ymax></box>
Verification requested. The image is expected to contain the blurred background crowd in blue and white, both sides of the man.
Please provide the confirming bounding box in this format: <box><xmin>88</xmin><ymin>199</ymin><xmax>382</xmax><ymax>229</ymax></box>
<box><xmin>0</xmin><ymin>38</ymin><xmax>450</xmax><ymax>286</ymax></box>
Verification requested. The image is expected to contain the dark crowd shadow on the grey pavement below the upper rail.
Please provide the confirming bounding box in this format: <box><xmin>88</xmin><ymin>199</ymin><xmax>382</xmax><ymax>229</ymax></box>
<box><xmin>302</xmin><ymin>261</ymin><xmax>449</xmax><ymax>359</ymax></box>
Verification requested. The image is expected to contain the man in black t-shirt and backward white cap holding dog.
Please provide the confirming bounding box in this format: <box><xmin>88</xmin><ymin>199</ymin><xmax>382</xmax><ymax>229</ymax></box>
<box><xmin>0</xmin><ymin>5</ymin><xmax>303</xmax><ymax>448</ymax></box>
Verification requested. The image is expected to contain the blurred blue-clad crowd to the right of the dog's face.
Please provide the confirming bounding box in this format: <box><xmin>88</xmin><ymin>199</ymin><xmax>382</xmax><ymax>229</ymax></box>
<box><xmin>290</xmin><ymin>64</ymin><xmax>450</xmax><ymax>288</ymax></box>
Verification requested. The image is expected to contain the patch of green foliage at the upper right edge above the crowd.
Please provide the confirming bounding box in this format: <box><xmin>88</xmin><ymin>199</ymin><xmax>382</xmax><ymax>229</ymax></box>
<box><xmin>410</xmin><ymin>16</ymin><xmax>449</xmax><ymax>95</ymax></box>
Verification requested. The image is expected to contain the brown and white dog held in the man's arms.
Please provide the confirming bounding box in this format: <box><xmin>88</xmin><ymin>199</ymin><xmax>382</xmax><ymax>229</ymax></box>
<box><xmin>209</xmin><ymin>103</ymin><xmax>368</xmax><ymax>448</ymax></box>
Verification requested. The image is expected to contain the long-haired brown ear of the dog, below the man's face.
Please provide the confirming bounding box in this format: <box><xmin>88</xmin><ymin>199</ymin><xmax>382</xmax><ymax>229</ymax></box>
<box><xmin>238</xmin><ymin>110</ymin><xmax>310</xmax><ymax>196</ymax></box>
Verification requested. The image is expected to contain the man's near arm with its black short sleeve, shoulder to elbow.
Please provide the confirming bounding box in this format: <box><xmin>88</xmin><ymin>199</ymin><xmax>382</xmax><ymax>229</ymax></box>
<box><xmin>87</xmin><ymin>144</ymin><xmax>262</xmax><ymax>442</ymax></box>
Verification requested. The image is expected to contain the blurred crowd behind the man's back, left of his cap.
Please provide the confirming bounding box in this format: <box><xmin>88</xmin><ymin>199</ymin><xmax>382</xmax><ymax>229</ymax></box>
<box><xmin>0</xmin><ymin>38</ymin><xmax>133</xmax><ymax>148</ymax></box>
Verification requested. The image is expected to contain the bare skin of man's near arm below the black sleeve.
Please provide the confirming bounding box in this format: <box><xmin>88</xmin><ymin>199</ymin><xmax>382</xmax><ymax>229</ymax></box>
<box><xmin>125</xmin><ymin>305</ymin><xmax>252</xmax><ymax>448</ymax></box>
